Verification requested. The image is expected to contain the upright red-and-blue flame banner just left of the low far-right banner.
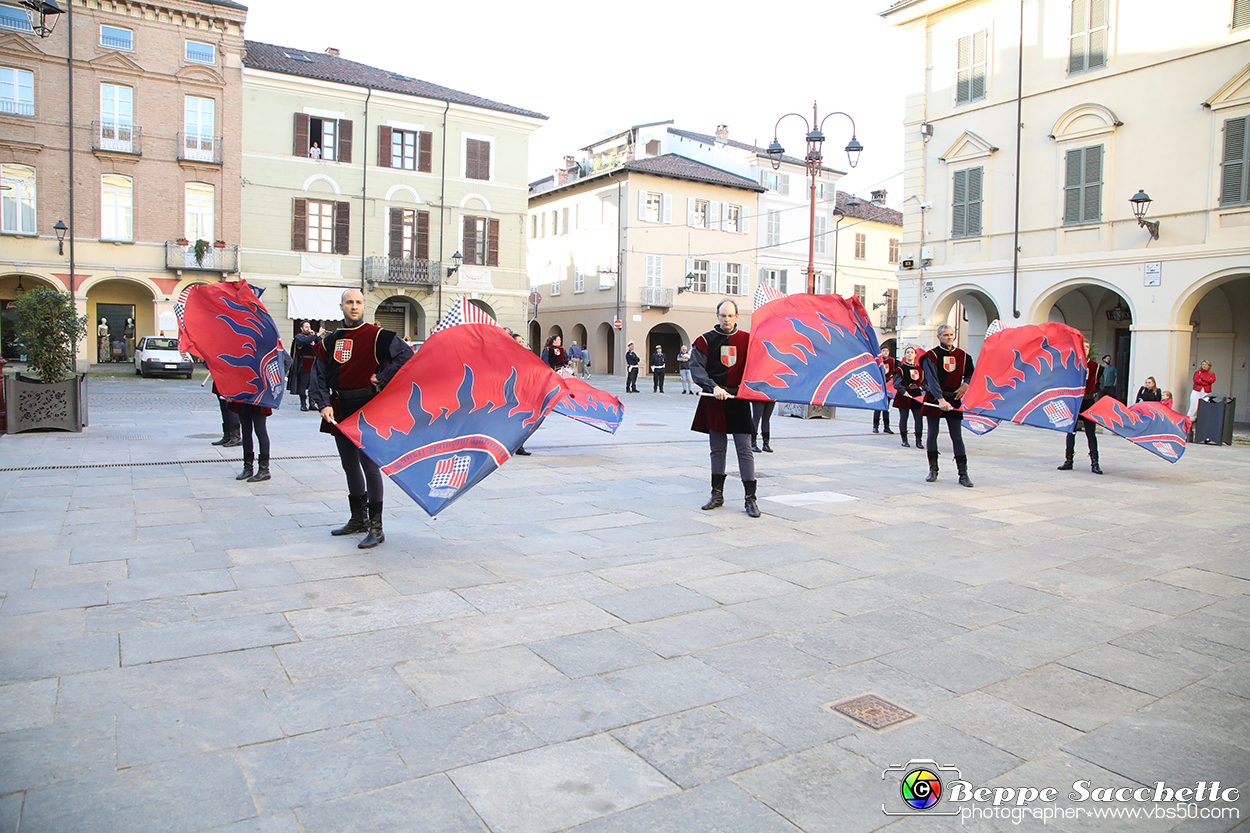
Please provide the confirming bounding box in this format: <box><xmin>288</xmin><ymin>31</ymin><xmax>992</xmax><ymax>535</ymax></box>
<box><xmin>964</xmin><ymin>323</ymin><xmax>1085</xmax><ymax>433</ymax></box>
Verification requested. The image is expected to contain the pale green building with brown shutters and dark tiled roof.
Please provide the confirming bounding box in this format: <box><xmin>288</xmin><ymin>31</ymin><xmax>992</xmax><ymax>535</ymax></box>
<box><xmin>243</xmin><ymin>41</ymin><xmax>545</xmax><ymax>341</ymax></box>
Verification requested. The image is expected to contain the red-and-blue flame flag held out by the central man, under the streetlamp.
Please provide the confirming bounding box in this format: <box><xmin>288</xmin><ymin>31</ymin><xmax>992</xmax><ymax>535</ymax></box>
<box><xmin>738</xmin><ymin>295</ymin><xmax>889</xmax><ymax>410</ymax></box>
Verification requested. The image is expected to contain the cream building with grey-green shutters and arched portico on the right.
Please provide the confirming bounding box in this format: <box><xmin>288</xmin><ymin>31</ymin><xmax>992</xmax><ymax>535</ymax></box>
<box><xmin>883</xmin><ymin>0</ymin><xmax>1250</xmax><ymax>420</ymax></box>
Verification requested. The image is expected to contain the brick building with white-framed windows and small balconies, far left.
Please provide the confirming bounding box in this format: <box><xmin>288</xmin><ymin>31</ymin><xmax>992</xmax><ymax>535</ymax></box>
<box><xmin>0</xmin><ymin>0</ymin><xmax>246</xmax><ymax>369</ymax></box>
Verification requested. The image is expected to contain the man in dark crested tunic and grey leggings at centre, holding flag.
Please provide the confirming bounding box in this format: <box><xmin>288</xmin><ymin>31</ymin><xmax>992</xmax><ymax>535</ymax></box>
<box><xmin>690</xmin><ymin>311</ymin><xmax>760</xmax><ymax>518</ymax></box>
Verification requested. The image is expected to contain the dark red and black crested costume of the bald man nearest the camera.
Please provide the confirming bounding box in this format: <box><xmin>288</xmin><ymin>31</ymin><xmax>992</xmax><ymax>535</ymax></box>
<box><xmin>309</xmin><ymin>316</ymin><xmax>413</xmax><ymax>549</ymax></box>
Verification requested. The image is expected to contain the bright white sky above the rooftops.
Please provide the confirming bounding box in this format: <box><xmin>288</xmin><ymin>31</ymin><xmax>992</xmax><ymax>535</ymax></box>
<box><xmin>243</xmin><ymin>0</ymin><xmax>909</xmax><ymax>208</ymax></box>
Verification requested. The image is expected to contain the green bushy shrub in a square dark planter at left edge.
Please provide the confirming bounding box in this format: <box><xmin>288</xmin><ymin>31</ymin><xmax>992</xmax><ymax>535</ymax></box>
<box><xmin>5</xmin><ymin>286</ymin><xmax>88</xmax><ymax>434</ymax></box>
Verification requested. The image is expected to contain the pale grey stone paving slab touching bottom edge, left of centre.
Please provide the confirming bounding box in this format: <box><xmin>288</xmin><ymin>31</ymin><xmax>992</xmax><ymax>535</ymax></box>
<box><xmin>450</xmin><ymin>735</ymin><xmax>678</xmax><ymax>833</ymax></box>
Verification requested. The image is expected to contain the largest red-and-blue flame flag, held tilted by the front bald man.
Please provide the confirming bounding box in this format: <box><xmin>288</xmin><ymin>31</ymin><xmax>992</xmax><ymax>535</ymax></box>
<box><xmin>339</xmin><ymin>324</ymin><xmax>565</xmax><ymax>517</ymax></box>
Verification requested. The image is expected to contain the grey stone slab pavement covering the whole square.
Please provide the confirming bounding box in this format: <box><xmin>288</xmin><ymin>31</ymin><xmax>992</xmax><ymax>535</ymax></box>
<box><xmin>0</xmin><ymin>376</ymin><xmax>1250</xmax><ymax>833</ymax></box>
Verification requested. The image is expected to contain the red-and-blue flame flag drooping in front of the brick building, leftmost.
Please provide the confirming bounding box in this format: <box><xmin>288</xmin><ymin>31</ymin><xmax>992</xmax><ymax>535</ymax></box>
<box><xmin>174</xmin><ymin>280</ymin><xmax>286</xmax><ymax>408</ymax></box>
